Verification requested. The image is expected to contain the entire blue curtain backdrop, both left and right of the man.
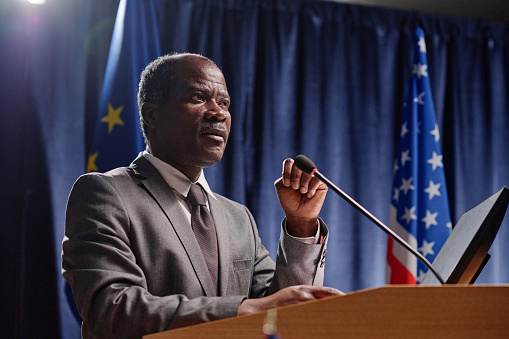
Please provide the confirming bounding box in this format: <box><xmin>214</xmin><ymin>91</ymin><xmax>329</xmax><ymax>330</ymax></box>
<box><xmin>0</xmin><ymin>0</ymin><xmax>509</xmax><ymax>338</ymax></box>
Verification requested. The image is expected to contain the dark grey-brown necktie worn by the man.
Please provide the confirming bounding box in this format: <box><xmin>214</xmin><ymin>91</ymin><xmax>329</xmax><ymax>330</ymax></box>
<box><xmin>187</xmin><ymin>184</ymin><xmax>218</xmax><ymax>289</ymax></box>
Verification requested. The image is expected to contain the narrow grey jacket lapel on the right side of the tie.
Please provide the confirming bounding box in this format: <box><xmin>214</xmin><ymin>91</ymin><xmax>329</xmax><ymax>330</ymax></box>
<box><xmin>209</xmin><ymin>195</ymin><xmax>231</xmax><ymax>295</ymax></box>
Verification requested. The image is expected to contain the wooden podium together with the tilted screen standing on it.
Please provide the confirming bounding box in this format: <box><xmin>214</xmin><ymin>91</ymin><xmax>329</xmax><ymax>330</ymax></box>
<box><xmin>144</xmin><ymin>187</ymin><xmax>509</xmax><ymax>339</ymax></box>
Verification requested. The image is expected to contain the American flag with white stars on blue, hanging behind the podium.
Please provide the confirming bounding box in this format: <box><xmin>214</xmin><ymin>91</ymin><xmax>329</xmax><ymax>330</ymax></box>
<box><xmin>387</xmin><ymin>27</ymin><xmax>452</xmax><ymax>284</ymax></box>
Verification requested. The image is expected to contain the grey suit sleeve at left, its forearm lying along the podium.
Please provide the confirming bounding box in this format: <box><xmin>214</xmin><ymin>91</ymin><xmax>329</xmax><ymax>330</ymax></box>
<box><xmin>62</xmin><ymin>175</ymin><xmax>244</xmax><ymax>338</ymax></box>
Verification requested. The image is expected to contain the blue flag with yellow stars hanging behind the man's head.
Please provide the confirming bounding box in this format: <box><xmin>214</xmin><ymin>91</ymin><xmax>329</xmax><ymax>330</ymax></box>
<box><xmin>87</xmin><ymin>0</ymin><xmax>161</xmax><ymax>172</ymax></box>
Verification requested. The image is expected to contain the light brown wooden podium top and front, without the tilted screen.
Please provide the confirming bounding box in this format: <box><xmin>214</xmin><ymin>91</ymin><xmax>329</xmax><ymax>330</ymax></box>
<box><xmin>144</xmin><ymin>285</ymin><xmax>509</xmax><ymax>339</ymax></box>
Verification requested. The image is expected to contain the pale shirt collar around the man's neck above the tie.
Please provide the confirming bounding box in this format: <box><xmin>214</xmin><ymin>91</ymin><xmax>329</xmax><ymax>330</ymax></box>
<box><xmin>143</xmin><ymin>151</ymin><xmax>216</xmax><ymax>199</ymax></box>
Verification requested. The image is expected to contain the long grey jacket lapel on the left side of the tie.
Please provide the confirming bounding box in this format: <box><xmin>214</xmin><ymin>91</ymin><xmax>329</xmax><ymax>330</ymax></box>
<box><xmin>130</xmin><ymin>153</ymin><xmax>219</xmax><ymax>296</ymax></box>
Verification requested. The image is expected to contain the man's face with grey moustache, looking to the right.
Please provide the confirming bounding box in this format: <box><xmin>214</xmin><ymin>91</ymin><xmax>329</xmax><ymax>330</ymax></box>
<box><xmin>151</xmin><ymin>56</ymin><xmax>231</xmax><ymax>176</ymax></box>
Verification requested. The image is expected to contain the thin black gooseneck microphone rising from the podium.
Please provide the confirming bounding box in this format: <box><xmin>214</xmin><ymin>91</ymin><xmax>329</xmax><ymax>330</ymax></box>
<box><xmin>294</xmin><ymin>155</ymin><xmax>445</xmax><ymax>285</ymax></box>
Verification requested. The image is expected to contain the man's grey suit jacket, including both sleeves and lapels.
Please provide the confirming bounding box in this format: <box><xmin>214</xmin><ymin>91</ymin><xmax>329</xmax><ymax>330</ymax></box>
<box><xmin>62</xmin><ymin>156</ymin><xmax>327</xmax><ymax>338</ymax></box>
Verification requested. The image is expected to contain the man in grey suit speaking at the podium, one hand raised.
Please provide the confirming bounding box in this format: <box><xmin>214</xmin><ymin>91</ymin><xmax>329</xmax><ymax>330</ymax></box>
<box><xmin>62</xmin><ymin>54</ymin><xmax>340</xmax><ymax>338</ymax></box>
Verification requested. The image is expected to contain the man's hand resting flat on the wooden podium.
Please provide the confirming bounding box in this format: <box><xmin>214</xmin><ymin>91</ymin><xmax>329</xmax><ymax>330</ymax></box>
<box><xmin>238</xmin><ymin>285</ymin><xmax>344</xmax><ymax>315</ymax></box>
